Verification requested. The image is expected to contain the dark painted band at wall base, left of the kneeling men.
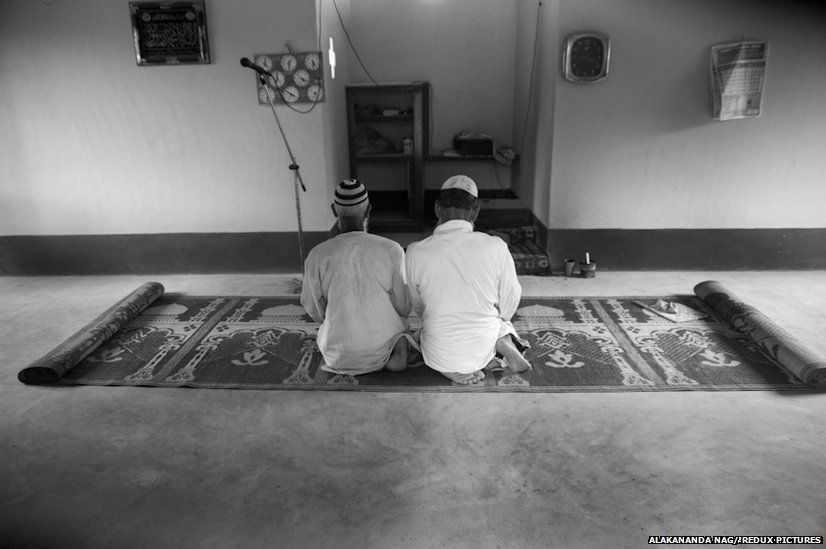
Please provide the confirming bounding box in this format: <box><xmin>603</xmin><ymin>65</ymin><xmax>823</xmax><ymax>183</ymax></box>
<box><xmin>0</xmin><ymin>232</ymin><xmax>328</xmax><ymax>276</ymax></box>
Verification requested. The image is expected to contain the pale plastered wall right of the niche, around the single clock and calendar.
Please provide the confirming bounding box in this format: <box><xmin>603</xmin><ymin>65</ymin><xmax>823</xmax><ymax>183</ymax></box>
<box><xmin>516</xmin><ymin>0</ymin><xmax>826</xmax><ymax>229</ymax></box>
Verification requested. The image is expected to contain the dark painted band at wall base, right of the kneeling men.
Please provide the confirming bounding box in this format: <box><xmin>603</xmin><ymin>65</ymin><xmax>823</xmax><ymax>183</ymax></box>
<box><xmin>535</xmin><ymin>227</ymin><xmax>826</xmax><ymax>270</ymax></box>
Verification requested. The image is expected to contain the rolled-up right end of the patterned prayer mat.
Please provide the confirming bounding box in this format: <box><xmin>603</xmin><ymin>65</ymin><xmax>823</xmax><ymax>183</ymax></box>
<box><xmin>694</xmin><ymin>280</ymin><xmax>826</xmax><ymax>387</ymax></box>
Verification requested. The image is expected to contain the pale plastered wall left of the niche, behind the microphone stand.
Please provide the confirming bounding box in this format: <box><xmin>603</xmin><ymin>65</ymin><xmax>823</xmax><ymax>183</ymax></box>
<box><xmin>0</xmin><ymin>0</ymin><xmax>340</xmax><ymax>235</ymax></box>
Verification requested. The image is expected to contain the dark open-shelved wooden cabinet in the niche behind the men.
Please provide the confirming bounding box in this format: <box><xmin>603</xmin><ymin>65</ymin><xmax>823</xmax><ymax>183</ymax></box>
<box><xmin>346</xmin><ymin>82</ymin><xmax>430</xmax><ymax>231</ymax></box>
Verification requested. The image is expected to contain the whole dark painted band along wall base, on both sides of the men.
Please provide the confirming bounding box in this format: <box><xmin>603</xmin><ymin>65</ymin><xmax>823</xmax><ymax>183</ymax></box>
<box><xmin>0</xmin><ymin>227</ymin><xmax>826</xmax><ymax>276</ymax></box>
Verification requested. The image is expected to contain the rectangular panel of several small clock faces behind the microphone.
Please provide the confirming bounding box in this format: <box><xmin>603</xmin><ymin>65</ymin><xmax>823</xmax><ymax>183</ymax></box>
<box><xmin>253</xmin><ymin>52</ymin><xmax>324</xmax><ymax>105</ymax></box>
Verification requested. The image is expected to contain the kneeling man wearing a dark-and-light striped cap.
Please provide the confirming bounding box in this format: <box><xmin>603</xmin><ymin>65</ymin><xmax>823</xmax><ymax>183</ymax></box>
<box><xmin>301</xmin><ymin>179</ymin><xmax>412</xmax><ymax>375</ymax></box>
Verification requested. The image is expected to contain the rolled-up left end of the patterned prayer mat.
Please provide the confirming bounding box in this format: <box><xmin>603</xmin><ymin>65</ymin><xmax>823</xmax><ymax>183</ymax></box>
<box><xmin>17</xmin><ymin>282</ymin><xmax>164</xmax><ymax>385</ymax></box>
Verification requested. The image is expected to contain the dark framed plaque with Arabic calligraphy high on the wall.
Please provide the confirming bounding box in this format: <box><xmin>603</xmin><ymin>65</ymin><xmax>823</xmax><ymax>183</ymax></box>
<box><xmin>129</xmin><ymin>0</ymin><xmax>209</xmax><ymax>65</ymax></box>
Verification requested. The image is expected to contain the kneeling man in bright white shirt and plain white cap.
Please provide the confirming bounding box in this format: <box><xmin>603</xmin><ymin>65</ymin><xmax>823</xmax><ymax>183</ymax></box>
<box><xmin>405</xmin><ymin>175</ymin><xmax>531</xmax><ymax>384</ymax></box>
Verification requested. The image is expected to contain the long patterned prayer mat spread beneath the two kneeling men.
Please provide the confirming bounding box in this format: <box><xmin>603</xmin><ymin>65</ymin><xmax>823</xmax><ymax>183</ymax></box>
<box><xmin>19</xmin><ymin>283</ymin><xmax>809</xmax><ymax>392</ymax></box>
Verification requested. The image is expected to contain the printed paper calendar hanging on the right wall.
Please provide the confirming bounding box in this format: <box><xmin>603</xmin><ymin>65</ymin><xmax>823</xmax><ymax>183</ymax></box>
<box><xmin>711</xmin><ymin>41</ymin><xmax>769</xmax><ymax>120</ymax></box>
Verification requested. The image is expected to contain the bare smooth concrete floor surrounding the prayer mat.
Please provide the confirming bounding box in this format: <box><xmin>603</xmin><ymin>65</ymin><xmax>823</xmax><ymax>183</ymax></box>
<box><xmin>0</xmin><ymin>271</ymin><xmax>826</xmax><ymax>549</ymax></box>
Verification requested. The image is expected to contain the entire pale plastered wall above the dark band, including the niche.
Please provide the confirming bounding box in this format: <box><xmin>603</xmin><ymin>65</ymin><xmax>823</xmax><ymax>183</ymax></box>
<box><xmin>0</xmin><ymin>0</ymin><xmax>826</xmax><ymax>240</ymax></box>
